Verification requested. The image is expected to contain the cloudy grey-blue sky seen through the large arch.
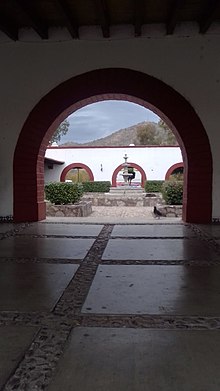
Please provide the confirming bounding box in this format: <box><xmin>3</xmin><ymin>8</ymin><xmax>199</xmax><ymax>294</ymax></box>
<box><xmin>60</xmin><ymin>100</ymin><xmax>159</xmax><ymax>144</ymax></box>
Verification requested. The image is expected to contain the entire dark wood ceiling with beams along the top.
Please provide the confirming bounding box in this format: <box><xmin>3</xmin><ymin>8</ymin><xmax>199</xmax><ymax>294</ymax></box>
<box><xmin>0</xmin><ymin>0</ymin><xmax>220</xmax><ymax>41</ymax></box>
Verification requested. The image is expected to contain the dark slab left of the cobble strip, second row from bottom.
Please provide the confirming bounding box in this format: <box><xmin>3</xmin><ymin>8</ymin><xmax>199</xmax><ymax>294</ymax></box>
<box><xmin>0</xmin><ymin>262</ymin><xmax>78</xmax><ymax>312</ymax></box>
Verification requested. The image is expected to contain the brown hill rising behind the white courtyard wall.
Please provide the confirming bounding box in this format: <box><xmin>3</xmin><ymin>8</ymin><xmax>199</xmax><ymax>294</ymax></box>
<box><xmin>60</xmin><ymin>121</ymin><xmax>177</xmax><ymax>147</ymax></box>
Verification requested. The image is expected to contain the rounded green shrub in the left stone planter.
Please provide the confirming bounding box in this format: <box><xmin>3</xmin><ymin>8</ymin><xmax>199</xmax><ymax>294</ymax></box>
<box><xmin>45</xmin><ymin>182</ymin><xmax>83</xmax><ymax>205</ymax></box>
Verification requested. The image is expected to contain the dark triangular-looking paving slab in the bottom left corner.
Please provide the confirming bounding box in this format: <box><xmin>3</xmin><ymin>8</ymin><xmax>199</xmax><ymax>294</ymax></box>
<box><xmin>0</xmin><ymin>326</ymin><xmax>37</xmax><ymax>389</ymax></box>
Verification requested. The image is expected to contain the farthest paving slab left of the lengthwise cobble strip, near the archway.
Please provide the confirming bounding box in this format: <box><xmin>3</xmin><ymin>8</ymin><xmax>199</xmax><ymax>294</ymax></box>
<box><xmin>24</xmin><ymin>223</ymin><xmax>103</xmax><ymax>236</ymax></box>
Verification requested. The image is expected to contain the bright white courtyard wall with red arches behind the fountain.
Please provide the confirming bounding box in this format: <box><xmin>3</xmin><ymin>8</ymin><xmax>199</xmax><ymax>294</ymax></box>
<box><xmin>44</xmin><ymin>147</ymin><xmax>183</xmax><ymax>182</ymax></box>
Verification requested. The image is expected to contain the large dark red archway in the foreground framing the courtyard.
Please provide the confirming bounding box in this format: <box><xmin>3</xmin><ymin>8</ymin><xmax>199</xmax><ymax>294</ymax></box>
<box><xmin>14</xmin><ymin>68</ymin><xmax>212</xmax><ymax>223</ymax></box>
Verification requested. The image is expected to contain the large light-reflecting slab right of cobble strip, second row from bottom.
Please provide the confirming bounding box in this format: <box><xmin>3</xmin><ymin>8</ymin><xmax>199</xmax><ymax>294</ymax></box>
<box><xmin>82</xmin><ymin>265</ymin><xmax>220</xmax><ymax>316</ymax></box>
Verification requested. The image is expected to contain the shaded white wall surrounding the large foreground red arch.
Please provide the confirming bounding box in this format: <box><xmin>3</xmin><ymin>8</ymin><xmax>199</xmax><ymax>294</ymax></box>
<box><xmin>0</xmin><ymin>27</ymin><xmax>220</xmax><ymax>217</ymax></box>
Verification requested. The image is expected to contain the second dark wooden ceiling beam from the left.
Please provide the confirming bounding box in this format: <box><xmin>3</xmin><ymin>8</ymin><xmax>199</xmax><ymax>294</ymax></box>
<box><xmin>15</xmin><ymin>0</ymin><xmax>48</xmax><ymax>39</ymax></box>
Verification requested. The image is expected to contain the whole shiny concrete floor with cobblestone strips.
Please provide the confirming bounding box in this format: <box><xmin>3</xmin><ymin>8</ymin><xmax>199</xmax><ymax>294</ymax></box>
<box><xmin>0</xmin><ymin>216</ymin><xmax>220</xmax><ymax>391</ymax></box>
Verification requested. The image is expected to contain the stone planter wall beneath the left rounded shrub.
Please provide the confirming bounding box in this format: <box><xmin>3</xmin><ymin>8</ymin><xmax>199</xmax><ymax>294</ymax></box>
<box><xmin>46</xmin><ymin>201</ymin><xmax>92</xmax><ymax>217</ymax></box>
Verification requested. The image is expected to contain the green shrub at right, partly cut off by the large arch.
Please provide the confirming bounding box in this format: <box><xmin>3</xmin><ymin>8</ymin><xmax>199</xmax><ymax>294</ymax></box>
<box><xmin>162</xmin><ymin>180</ymin><xmax>183</xmax><ymax>205</ymax></box>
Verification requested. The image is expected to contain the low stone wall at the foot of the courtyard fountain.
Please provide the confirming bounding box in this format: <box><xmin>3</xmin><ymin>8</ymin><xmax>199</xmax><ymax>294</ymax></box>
<box><xmin>82</xmin><ymin>193</ymin><xmax>163</xmax><ymax>207</ymax></box>
